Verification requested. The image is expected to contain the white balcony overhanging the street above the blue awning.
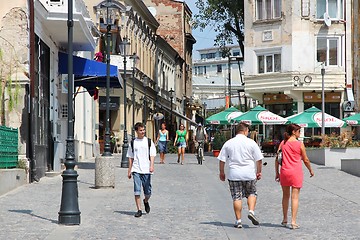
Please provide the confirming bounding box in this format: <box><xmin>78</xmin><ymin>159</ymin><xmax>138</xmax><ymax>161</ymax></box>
<box><xmin>35</xmin><ymin>0</ymin><xmax>96</xmax><ymax>51</ymax></box>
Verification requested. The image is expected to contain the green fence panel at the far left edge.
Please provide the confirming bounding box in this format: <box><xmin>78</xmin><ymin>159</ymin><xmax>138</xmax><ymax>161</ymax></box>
<box><xmin>0</xmin><ymin>126</ymin><xmax>19</xmax><ymax>168</ymax></box>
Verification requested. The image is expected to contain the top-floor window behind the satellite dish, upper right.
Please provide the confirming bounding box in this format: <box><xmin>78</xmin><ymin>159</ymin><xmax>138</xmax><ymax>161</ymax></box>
<box><xmin>316</xmin><ymin>0</ymin><xmax>344</xmax><ymax>19</ymax></box>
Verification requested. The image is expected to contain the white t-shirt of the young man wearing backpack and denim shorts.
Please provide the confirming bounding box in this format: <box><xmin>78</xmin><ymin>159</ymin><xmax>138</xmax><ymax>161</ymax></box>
<box><xmin>126</xmin><ymin>137</ymin><xmax>156</xmax><ymax>174</ymax></box>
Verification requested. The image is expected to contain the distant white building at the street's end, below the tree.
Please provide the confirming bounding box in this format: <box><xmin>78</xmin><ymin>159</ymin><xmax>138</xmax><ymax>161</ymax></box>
<box><xmin>193</xmin><ymin>45</ymin><xmax>252</xmax><ymax>111</ymax></box>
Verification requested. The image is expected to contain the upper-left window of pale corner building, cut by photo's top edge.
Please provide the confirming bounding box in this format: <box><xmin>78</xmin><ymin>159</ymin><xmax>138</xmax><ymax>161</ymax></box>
<box><xmin>256</xmin><ymin>0</ymin><xmax>281</xmax><ymax>20</ymax></box>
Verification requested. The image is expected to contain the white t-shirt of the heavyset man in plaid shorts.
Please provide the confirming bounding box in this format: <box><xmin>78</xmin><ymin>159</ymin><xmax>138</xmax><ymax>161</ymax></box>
<box><xmin>218</xmin><ymin>134</ymin><xmax>264</xmax><ymax>181</ymax></box>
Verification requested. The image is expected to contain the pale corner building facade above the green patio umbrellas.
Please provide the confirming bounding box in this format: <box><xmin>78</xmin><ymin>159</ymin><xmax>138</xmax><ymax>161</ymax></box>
<box><xmin>244</xmin><ymin>0</ymin><xmax>354</xmax><ymax>131</ymax></box>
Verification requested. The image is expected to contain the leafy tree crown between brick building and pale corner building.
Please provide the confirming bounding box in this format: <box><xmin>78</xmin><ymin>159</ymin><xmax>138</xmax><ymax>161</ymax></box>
<box><xmin>193</xmin><ymin>0</ymin><xmax>244</xmax><ymax>56</ymax></box>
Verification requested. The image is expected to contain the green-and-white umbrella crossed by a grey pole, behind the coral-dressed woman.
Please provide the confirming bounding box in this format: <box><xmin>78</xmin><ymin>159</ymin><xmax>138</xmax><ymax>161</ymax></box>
<box><xmin>287</xmin><ymin>107</ymin><xmax>346</xmax><ymax>128</ymax></box>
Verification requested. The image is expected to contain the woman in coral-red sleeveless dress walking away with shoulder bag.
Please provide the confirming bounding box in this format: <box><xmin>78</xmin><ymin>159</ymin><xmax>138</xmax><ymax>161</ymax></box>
<box><xmin>275</xmin><ymin>124</ymin><xmax>314</xmax><ymax>229</ymax></box>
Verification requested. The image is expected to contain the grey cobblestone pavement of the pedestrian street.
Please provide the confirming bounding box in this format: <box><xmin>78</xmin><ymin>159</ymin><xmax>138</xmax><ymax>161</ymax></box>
<box><xmin>0</xmin><ymin>154</ymin><xmax>360</xmax><ymax>240</ymax></box>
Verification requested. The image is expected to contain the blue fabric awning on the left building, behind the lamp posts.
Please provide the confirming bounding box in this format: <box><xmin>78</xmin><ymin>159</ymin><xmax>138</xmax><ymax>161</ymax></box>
<box><xmin>59</xmin><ymin>52</ymin><xmax>123</xmax><ymax>91</ymax></box>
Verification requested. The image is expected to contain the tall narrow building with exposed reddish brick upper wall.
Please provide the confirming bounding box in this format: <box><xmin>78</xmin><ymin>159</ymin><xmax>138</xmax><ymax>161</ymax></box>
<box><xmin>143</xmin><ymin>0</ymin><xmax>196</xmax><ymax>131</ymax></box>
